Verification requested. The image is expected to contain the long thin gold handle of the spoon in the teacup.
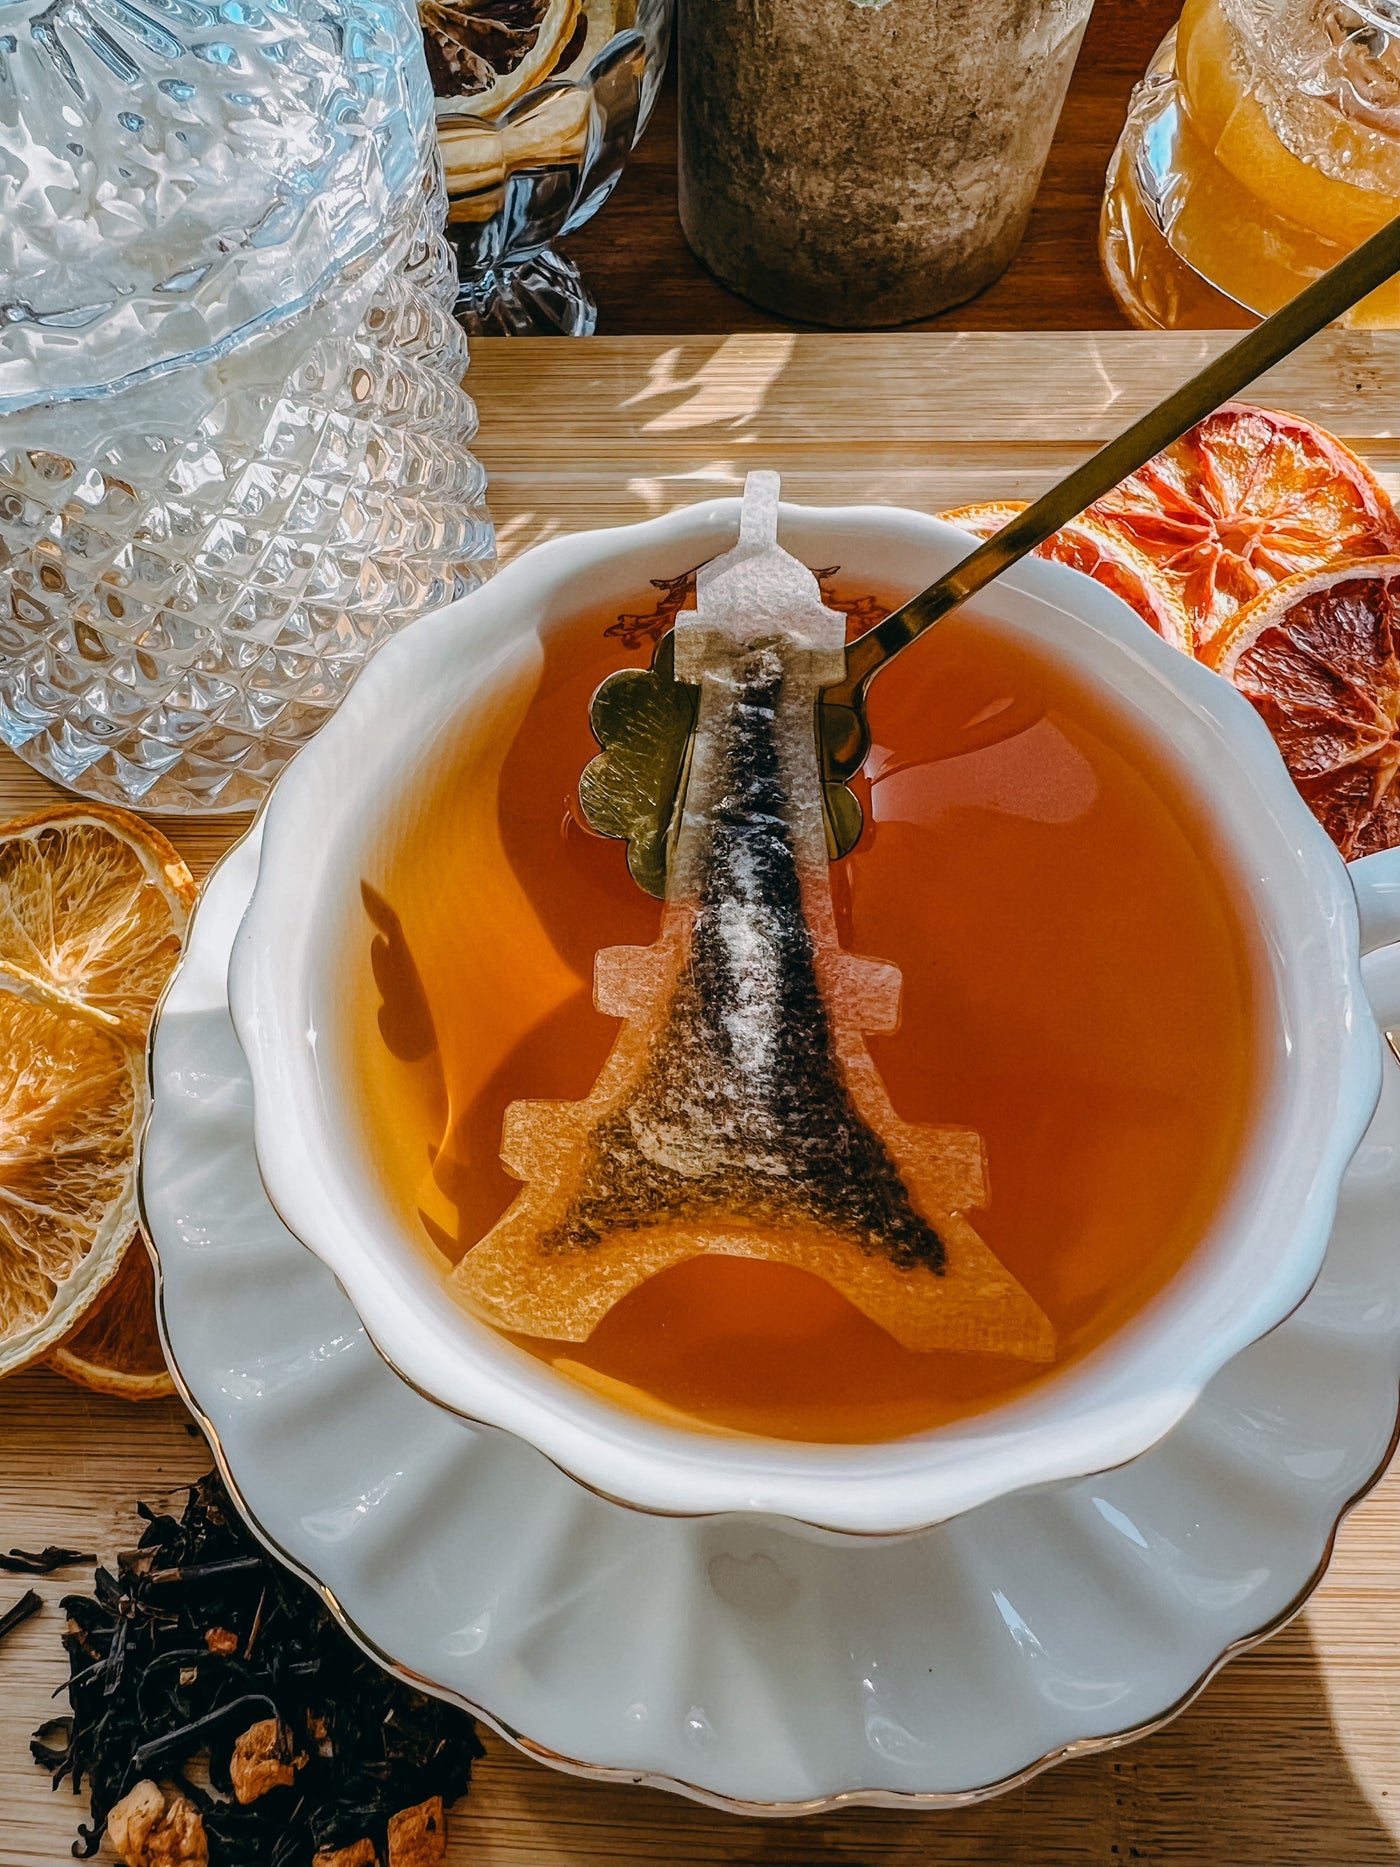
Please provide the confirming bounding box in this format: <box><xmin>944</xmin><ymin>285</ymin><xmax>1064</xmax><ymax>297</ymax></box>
<box><xmin>821</xmin><ymin>215</ymin><xmax>1400</xmax><ymax>782</ymax></box>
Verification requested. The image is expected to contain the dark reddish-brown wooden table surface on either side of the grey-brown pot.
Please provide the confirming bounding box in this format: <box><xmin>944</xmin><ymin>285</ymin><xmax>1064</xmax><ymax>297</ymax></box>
<box><xmin>566</xmin><ymin>0</ymin><xmax>1182</xmax><ymax>336</ymax></box>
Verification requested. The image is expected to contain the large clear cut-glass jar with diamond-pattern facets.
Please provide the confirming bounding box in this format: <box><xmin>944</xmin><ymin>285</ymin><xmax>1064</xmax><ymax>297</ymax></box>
<box><xmin>0</xmin><ymin>0</ymin><xmax>493</xmax><ymax>810</ymax></box>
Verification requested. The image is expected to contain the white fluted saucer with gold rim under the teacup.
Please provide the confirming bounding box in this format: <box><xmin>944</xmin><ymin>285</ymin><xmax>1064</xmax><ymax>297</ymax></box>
<box><xmin>144</xmin><ymin>831</ymin><xmax>1400</xmax><ymax>1815</ymax></box>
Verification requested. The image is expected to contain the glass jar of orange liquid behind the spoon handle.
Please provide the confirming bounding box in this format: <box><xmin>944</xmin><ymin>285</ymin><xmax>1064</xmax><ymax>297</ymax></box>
<box><xmin>1099</xmin><ymin>0</ymin><xmax>1400</xmax><ymax>329</ymax></box>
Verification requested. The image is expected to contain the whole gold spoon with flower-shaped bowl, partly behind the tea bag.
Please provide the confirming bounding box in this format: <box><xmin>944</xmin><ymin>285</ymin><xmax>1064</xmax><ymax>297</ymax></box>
<box><xmin>579</xmin><ymin>217</ymin><xmax>1400</xmax><ymax>896</ymax></box>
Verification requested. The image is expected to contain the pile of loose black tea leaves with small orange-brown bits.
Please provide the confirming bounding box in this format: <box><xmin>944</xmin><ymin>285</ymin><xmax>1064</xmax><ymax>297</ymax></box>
<box><xmin>34</xmin><ymin>1473</ymin><xmax>482</xmax><ymax>1867</ymax></box>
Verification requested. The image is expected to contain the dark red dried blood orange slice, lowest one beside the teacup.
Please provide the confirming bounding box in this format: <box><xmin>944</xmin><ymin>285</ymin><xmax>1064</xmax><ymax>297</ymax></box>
<box><xmin>1211</xmin><ymin>556</ymin><xmax>1400</xmax><ymax>857</ymax></box>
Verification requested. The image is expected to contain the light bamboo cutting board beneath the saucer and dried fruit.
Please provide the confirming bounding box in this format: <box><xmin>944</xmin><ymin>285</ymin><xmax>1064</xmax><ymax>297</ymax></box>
<box><xmin>0</xmin><ymin>332</ymin><xmax>1400</xmax><ymax>1867</ymax></box>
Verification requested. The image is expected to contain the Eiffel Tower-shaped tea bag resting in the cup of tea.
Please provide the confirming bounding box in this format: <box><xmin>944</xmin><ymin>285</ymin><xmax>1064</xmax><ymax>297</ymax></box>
<box><xmin>454</xmin><ymin>474</ymin><xmax>1055</xmax><ymax>1361</ymax></box>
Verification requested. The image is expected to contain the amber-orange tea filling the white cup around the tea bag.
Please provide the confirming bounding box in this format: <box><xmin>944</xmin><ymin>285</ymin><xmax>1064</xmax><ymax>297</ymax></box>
<box><xmin>351</xmin><ymin>584</ymin><xmax>1262</xmax><ymax>1441</ymax></box>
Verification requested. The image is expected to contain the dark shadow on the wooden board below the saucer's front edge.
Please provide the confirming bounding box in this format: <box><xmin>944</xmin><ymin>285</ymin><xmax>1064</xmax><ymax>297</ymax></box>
<box><xmin>461</xmin><ymin>1617</ymin><xmax>1400</xmax><ymax>1867</ymax></box>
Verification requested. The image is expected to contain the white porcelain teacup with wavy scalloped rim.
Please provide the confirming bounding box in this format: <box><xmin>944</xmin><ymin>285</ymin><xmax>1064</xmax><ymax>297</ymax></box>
<box><xmin>230</xmin><ymin>498</ymin><xmax>1400</xmax><ymax>1535</ymax></box>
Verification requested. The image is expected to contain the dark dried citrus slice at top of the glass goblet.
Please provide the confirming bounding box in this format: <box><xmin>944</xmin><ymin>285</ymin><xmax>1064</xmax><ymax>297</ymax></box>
<box><xmin>418</xmin><ymin>0</ymin><xmax>581</xmax><ymax>116</ymax></box>
